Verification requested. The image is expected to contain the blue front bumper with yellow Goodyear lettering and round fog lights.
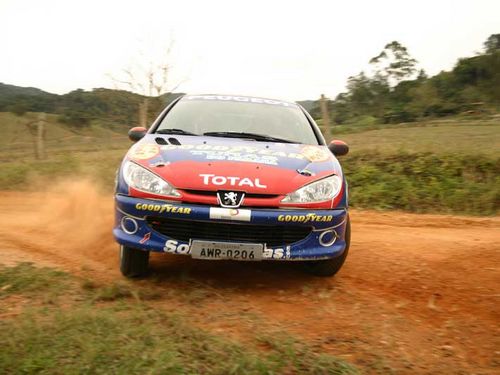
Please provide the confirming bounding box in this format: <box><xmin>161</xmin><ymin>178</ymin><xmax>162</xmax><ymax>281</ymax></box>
<box><xmin>113</xmin><ymin>194</ymin><xmax>348</xmax><ymax>261</ymax></box>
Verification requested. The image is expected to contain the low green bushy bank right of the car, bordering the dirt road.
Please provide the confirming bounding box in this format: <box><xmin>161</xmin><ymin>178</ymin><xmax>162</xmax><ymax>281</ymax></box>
<box><xmin>343</xmin><ymin>152</ymin><xmax>500</xmax><ymax>215</ymax></box>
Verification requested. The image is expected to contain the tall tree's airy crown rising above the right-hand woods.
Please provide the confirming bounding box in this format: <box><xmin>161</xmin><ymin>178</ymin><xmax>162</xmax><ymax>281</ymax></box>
<box><xmin>370</xmin><ymin>41</ymin><xmax>417</xmax><ymax>87</ymax></box>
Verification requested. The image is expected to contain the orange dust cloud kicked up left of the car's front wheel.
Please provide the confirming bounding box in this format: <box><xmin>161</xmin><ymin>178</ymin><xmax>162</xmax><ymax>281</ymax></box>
<box><xmin>0</xmin><ymin>177</ymin><xmax>118</xmax><ymax>270</ymax></box>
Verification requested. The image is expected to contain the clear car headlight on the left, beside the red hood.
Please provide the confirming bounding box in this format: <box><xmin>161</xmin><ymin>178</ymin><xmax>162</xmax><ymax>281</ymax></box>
<box><xmin>123</xmin><ymin>161</ymin><xmax>181</xmax><ymax>197</ymax></box>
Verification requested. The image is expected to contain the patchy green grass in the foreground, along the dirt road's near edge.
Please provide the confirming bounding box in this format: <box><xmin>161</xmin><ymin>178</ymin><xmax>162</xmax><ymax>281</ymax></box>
<box><xmin>0</xmin><ymin>264</ymin><xmax>357</xmax><ymax>374</ymax></box>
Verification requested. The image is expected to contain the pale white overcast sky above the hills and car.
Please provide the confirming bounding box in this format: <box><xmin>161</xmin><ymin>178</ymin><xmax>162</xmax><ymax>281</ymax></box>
<box><xmin>0</xmin><ymin>0</ymin><xmax>500</xmax><ymax>100</ymax></box>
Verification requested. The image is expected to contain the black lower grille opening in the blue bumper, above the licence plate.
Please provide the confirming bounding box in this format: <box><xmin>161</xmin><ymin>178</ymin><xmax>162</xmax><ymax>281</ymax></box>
<box><xmin>147</xmin><ymin>217</ymin><xmax>312</xmax><ymax>246</ymax></box>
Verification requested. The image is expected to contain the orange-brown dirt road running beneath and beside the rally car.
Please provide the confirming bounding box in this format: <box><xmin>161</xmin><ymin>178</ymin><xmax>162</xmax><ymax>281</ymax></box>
<box><xmin>0</xmin><ymin>181</ymin><xmax>500</xmax><ymax>374</ymax></box>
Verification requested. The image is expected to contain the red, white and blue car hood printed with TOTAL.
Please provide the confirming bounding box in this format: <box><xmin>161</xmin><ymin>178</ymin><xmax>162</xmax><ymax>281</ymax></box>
<box><xmin>127</xmin><ymin>134</ymin><xmax>342</xmax><ymax>195</ymax></box>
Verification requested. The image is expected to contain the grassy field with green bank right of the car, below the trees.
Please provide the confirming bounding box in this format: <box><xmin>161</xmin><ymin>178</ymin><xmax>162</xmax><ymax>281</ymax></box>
<box><xmin>340</xmin><ymin>119</ymin><xmax>500</xmax><ymax>215</ymax></box>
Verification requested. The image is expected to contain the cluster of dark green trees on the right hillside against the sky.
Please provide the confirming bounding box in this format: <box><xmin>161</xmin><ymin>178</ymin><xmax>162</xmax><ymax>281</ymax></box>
<box><xmin>313</xmin><ymin>34</ymin><xmax>500</xmax><ymax>124</ymax></box>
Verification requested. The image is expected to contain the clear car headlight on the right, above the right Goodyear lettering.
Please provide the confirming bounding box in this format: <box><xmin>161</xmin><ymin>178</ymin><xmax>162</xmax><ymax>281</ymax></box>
<box><xmin>281</xmin><ymin>175</ymin><xmax>342</xmax><ymax>203</ymax></box>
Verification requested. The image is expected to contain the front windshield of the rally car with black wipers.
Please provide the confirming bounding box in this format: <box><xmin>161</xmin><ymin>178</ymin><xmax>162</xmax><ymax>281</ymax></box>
<box><xmin>156</xmin><ymin>95</ymin><xmax>318</xmax><ymax>145</ymax></box>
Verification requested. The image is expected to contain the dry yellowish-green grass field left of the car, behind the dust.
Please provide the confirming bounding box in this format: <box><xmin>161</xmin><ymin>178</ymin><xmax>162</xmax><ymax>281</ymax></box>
<box><xmin>0</xmin><ymin>112</ymin><xmax>131</xmax><ymax>190</ymax></box>
